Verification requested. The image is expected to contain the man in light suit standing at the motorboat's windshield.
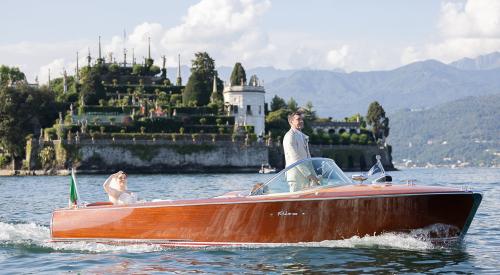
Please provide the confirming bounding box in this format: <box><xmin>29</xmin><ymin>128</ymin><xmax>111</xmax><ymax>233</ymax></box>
<box><xmin>283</xmin><ymin>111</ymin><xmax>319</xmax><ymax>192</ymax></box>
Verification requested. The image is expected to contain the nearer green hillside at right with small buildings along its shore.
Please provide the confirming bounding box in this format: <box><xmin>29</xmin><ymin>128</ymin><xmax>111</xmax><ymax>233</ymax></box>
<box><xmin>389</xmin><ymin>94</ymin><xmax>500</xmax><ymax>166</ymax></box>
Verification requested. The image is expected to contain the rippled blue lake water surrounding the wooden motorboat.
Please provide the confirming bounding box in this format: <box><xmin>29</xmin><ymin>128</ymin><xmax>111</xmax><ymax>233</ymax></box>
<box><xmin>0</xmin><ymin>168</ymin><xmax>500</xmax><ymax>274</ymax></box>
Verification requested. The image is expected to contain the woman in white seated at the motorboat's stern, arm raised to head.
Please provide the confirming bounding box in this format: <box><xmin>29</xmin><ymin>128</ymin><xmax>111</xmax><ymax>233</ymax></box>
<box><xmin>102</xmin><ymin>171</ymin><xmax>137</xmax><ymax>205</ymax></box>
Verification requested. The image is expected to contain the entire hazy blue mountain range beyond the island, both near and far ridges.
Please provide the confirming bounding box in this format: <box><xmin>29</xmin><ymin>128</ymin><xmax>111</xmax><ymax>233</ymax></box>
<box><xmin>169</xmin><ymin>52</ymin><xmax>500</xmax><ymax>166</ymax></box>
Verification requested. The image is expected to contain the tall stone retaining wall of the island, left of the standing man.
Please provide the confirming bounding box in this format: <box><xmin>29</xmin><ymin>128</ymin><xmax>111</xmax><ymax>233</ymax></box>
<box><xmin>27</xmin><ymin>139</ymin><xmax>269</xmax><ymax>173</ymax></box>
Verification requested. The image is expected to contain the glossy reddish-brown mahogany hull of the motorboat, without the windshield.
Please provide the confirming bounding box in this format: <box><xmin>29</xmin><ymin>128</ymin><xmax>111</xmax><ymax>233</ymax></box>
<box><xmin>51</xmin><ymin>188</ymin><xmax>481</xmax><ymax>244</ymax></box>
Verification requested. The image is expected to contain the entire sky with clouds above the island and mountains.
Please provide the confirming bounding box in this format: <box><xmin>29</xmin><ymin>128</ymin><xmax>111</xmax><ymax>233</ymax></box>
<box><xmin>0</xmin><ymin>0</ymin><xmax>500</xmax><ymax>83</ymax></box>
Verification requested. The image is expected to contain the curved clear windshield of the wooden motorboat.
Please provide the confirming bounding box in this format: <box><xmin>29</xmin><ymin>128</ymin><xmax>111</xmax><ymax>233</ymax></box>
<box><xmin>250</xmin><ymin>158</ymin><xmax>351</xmax><ymax>196</ymax></box>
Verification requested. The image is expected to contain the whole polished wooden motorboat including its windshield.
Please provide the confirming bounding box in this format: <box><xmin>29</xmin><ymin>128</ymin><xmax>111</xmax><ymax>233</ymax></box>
<box><xmin>51</xmin><ymin>158</ymin><xmax>482</xmax><ymax>246</ymax></box>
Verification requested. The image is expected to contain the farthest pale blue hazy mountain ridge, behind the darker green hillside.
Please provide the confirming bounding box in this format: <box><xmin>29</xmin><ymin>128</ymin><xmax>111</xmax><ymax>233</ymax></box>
<box><xmin>266</xmin><ymin>60</ymin><xmax>500</xmax><ymax>118</ymax></box>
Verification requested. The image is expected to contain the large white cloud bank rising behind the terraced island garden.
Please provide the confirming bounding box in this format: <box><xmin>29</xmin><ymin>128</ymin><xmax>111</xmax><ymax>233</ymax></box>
<box><xmin>0</xmin><ymin>0</ymin><xmax>276</xmax><ymax>83</ymax></box>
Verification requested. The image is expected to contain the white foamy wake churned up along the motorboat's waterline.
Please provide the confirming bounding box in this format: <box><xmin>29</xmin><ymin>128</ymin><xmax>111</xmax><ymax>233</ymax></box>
<box><xmin>0</xmin><ymin>222</ymin><xmax>451</xmax><ymax>253</ymax></box>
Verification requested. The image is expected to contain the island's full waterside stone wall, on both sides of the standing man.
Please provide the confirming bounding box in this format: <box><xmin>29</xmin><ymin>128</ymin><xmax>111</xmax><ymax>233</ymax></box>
<box><xmin>21</xmin><ymin>139</ymin><xmax>394</xmax><ymax>173</ymax></box>
